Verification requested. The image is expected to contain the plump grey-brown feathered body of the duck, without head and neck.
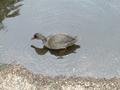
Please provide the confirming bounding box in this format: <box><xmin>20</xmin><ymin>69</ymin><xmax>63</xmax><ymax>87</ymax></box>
<box><xmin>45</xmin><ymin>34</ymin><xmax>76</xmax><ymax>49</ymax></box>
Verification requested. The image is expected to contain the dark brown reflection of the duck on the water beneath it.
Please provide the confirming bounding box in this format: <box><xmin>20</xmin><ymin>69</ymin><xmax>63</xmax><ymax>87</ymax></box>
<box><xmin>31</xmin><ymin>44</ymin><xmax>80</xmax><ymax>59</ymax></box>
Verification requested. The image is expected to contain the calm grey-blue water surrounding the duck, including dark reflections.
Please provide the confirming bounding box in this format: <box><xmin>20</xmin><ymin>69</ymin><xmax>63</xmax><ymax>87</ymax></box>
<box><xmin>0</xmin><ymin>0</ymin><xmax>120</xmax><ymax>77</ymax></box>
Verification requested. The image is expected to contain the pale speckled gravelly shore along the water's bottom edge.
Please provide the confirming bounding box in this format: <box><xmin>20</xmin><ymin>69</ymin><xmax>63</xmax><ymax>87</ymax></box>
<box><xmin>0</xmin><ymin>65</ymin><xmax>120</xmax><ymax>90</ymax></box>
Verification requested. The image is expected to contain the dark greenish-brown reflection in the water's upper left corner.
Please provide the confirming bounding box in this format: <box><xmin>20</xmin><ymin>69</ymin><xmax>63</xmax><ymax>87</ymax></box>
<box><xmin>0</xmin><ymin>0</ymin><xmax>23</xmax><ymax>30</ymax></box>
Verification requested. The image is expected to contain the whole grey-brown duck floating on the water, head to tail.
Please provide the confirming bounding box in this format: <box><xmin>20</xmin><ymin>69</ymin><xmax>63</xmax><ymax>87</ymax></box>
<box><xmin>31</xmin><ymin>33</ymin><xmax>77</xmax><ymax>50</ymax></box>
